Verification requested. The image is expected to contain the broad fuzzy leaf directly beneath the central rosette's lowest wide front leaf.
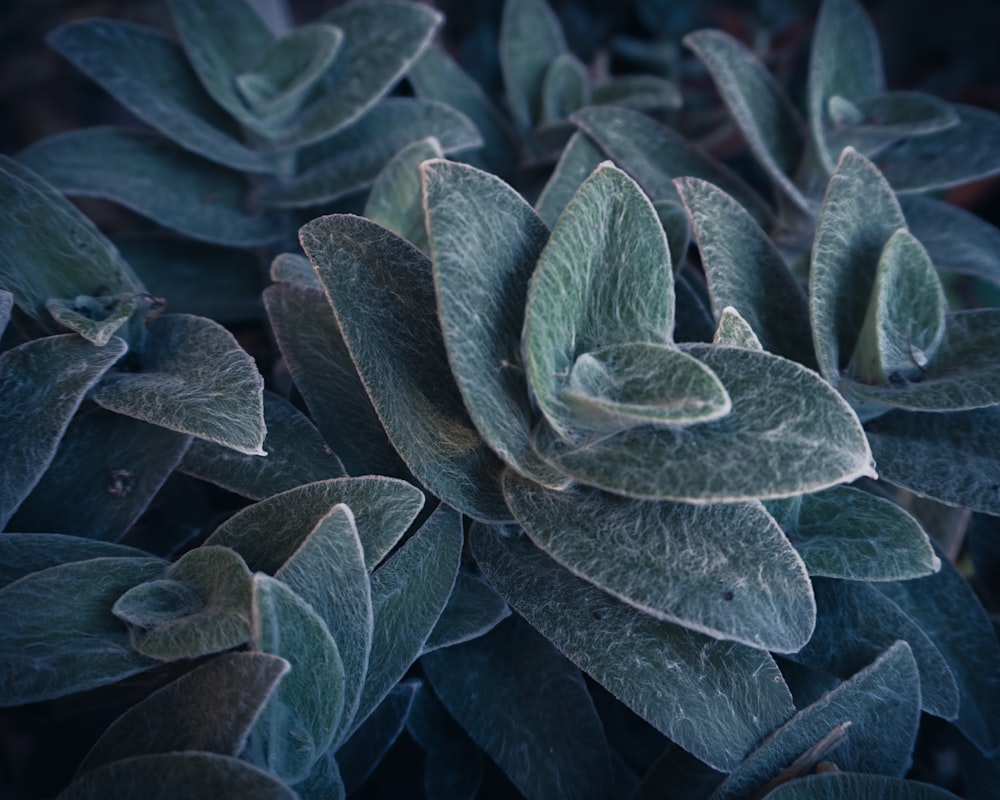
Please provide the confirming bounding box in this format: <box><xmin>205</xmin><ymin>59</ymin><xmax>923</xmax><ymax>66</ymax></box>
<box><xmin>504</xmin><ymin>473</ymin><xmax>816</xmax><ymax>653</ymax></box>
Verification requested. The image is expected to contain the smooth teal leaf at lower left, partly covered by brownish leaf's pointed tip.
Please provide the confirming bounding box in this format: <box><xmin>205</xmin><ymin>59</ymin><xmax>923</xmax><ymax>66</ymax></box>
<box><xmin>249</xmin><ymin>573</ymin><xmax>344</xmax><ymax>783</ymax></box>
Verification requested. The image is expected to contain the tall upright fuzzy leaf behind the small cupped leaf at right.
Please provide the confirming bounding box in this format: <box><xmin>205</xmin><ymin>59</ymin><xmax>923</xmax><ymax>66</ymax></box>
<box><xmin>809</xmin><ymin>151</ymin><xmax>906</xmax><ymax>385</ymax></box>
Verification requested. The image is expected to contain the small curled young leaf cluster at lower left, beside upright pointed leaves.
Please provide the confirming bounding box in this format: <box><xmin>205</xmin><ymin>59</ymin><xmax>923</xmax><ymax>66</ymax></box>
<box><xmin>112</xmin><ymin>546</ymin><xmax>252</xmax><ymax>661</ymax></box>
